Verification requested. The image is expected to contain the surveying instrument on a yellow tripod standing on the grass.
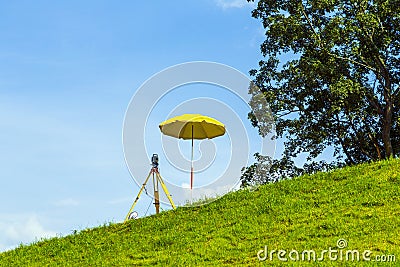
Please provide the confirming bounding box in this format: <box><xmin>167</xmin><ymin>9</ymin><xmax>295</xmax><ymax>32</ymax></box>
<box><xmin>124</xmin><ymin>154</ymin><xmax>176</xmax><ymax>222</ymax></box>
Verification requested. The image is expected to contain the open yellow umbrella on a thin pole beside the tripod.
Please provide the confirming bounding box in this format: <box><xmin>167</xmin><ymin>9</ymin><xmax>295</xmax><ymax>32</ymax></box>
<box><xmin>159</xmin><ymin>114</ymin><xmax>225</xmax><ymax>189</ymax></box>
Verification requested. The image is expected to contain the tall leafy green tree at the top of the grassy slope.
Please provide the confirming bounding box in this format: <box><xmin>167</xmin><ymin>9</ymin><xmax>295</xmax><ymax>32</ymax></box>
<box><xmin>244</xmin><ymin>0</ymin><xmax>400</xmax><ymax>180</ymax></box>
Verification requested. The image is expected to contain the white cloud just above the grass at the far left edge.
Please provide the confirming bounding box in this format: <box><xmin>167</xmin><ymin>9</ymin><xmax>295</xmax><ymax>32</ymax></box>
<box><xmin>0</xmin><ymin>215</ymin><xmax>57</xmax><ymax>252</ymax></box>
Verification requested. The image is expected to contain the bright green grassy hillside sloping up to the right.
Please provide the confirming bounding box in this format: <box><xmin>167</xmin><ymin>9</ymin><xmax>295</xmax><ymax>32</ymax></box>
<box><xmin>0</xmin><ymin>160</ymin><xmax>400</xmax><ymax>266</ymax></box>
